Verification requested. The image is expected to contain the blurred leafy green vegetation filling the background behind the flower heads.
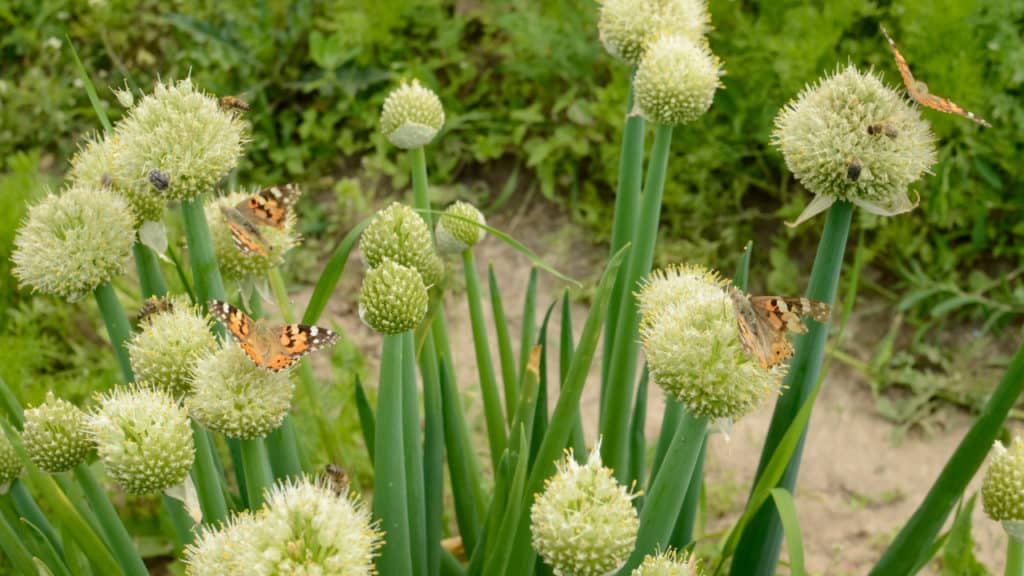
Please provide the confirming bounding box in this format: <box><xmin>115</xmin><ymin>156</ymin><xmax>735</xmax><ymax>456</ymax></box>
<box><xmin>0</xmin><ymin>0</ymin><xmax>1024</xmax><ymax>444</ymax></box>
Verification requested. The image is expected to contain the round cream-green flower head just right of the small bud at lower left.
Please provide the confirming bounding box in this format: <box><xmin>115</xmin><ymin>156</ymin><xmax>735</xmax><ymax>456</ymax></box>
<box><xmin>88</xmin><ymin>385</ymin><xmax>196</xmax><ymax>494</ymax></box>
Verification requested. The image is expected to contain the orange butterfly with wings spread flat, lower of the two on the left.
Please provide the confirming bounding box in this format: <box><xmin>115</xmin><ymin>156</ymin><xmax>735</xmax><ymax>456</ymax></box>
<box><xmin>206</xmin><ymin>300</ymin><xmax>338</xmax><ymax>372</ymax></box>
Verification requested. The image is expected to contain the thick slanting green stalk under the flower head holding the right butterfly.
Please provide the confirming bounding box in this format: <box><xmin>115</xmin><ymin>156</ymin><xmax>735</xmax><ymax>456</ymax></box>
<box><xmin>618</xmin><ymin>413</ymin><xmax>708</xmax><ymax>575</ymax></box>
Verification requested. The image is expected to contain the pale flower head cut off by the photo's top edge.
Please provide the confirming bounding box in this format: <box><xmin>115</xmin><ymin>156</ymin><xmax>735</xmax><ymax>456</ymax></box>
<box><xmin>597</xmin><ymin>0</ymin><xmax>711</xmax><ymax>66</ymax></box>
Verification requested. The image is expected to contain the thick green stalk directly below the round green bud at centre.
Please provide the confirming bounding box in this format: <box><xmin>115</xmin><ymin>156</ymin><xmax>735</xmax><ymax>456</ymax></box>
<box><xmin>373</xmin><ymin>334</ymin><xmax>414</xmax><ymax>574</ymax></box>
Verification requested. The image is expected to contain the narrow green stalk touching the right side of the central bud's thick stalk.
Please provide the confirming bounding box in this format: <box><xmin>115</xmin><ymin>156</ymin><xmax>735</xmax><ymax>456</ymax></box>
<box><xmin>401</xmin><ymin>331</ymin><xmax>425</xmax><ymax>576</ymax></box>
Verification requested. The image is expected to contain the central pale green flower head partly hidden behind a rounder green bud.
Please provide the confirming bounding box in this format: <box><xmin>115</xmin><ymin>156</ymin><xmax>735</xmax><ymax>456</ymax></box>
<box><xmin>359</xmin><ymin>202</ymin><xmax>440</xmax><ymax>286</ymax></box>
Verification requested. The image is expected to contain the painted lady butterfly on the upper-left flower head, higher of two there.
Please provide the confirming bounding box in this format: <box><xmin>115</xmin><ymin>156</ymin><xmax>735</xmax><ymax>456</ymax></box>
<box><xmin>220</xmin><ymin>184</ymin><xmax>302</xmax><ymax>256</ymax></box>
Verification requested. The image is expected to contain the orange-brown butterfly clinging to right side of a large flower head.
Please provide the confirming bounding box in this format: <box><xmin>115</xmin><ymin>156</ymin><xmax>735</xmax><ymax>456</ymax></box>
<box><xmin>729</xmin><ymin>288</ymin><xmax>831</xmax><ymax>369</ymax></box>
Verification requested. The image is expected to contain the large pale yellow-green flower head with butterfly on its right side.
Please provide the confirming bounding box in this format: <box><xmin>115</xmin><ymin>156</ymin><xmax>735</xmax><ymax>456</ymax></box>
<box><xmin>637</xmin><ymin>266</ymin><xmax>784</xmax><ymax>420</ymax></box>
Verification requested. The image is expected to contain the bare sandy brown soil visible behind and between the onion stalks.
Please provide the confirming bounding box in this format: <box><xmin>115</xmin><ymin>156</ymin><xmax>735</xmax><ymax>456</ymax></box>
<box><xmin>309</xmin><ymin>200</ymin><xmax>1005</xmax><ymax>576</ymax></box>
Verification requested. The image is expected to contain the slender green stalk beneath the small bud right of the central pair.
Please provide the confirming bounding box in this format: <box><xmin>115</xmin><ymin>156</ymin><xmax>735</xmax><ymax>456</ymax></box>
<box><xmin>462</xmin><ymin>250</ymin><xmax>507</xmax><ymax>468</ymax></box>
